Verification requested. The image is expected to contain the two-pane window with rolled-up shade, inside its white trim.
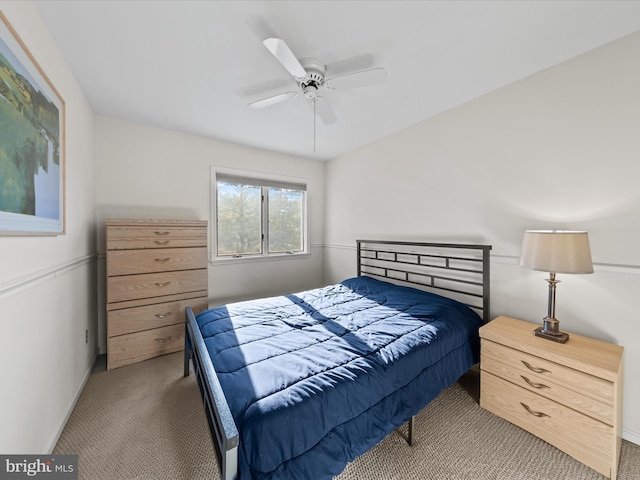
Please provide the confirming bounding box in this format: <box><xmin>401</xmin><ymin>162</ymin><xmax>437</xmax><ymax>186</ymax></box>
<box><xmin>212</xmin><ymin>172</ymin><xmax>307</xmax><ymax>259</ymax></box>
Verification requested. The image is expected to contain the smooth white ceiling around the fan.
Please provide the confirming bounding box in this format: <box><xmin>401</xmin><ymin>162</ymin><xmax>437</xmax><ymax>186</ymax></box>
<box><xmin>34</xmin><ymin>0</ymin><xmax>640</xmax><ymax>159</ymax></box>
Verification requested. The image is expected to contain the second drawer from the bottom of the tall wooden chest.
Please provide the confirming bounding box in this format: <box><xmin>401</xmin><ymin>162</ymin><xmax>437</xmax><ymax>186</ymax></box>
<box><xmin>107</xmin><ymin>297</ymin><xmax>208</xmax><ymax>337</ymax></box>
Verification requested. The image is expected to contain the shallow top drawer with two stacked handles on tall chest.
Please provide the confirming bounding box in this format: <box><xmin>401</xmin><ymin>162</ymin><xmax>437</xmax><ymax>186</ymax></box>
<box><xmin>107</xmin><ymin>225</ymin><xmax>207</xmax><ymax>250</ymax></box>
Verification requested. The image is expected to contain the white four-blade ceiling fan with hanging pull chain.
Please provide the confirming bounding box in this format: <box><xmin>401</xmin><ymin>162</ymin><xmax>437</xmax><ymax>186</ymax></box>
<box><xmin>249</xmin><ymin>37</ymin><xmax>387</xmax><ymax>127</ymax></box>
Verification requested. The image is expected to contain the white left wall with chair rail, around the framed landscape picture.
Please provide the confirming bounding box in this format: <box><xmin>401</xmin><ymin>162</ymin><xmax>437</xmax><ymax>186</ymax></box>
<box><xmin>0</xmin><ymin>2</ymin><xmax>97</xmax><ymax>454</ymax></box>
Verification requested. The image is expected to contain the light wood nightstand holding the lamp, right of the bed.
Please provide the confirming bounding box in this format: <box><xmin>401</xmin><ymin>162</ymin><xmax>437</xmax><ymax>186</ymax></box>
<box><xmin>480</xmin><ymin>317</ymin><xmax>623</xmax><ymax>479</ymax></box>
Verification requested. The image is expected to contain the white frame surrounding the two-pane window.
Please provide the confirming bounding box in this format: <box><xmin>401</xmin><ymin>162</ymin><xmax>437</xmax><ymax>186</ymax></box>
<box><xmin>209</xmin><ymin>166</ymin><xmax>309</xmax><ymax>263</ymax></box>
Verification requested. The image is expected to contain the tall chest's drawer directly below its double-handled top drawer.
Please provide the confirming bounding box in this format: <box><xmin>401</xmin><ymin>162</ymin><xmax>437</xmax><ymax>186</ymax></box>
<box><xmin>107</xmin><ymin>247</ymin><xmax>207</xmax><ymax>277</ymax></box>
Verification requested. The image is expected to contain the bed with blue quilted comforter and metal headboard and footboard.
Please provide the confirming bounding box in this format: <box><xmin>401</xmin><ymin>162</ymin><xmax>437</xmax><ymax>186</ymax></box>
<box><xmin>184</xmin><ymin>240</ymin><xmax>491</xmax><ymax>480</ymax></box>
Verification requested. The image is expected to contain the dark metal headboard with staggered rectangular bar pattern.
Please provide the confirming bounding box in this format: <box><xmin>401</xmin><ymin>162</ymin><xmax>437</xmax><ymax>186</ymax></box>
<box><xmin>356</xmin><ymin>240</ymin><xmax>491</xmax><ymax>322</ymax></box>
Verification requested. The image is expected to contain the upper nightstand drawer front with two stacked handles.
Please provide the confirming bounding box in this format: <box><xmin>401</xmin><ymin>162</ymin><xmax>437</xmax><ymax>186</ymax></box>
<box><xmin>481</xmin><ymin>340</ymin><xmax>614</xmax><ymax>425</ymax></box>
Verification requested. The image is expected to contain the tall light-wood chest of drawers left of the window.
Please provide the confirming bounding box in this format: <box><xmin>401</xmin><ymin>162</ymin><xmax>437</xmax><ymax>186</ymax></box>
<box><xmin>105</xmin><ymin>219</ymin><xmax>208</xmax><ymax>369</ymax></box>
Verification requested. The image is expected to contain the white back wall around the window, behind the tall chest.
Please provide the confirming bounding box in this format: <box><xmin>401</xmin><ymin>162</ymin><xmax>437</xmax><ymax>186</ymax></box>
<box><xmin>96</xmin><ymin>116</ymin><xmax>324</xmax><ymax>350</ymax></box>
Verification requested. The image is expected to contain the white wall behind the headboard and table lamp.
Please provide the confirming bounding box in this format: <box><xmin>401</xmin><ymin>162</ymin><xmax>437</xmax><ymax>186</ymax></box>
<box><xmin>325</xmin><ymin>33</ymin><xmax>640</xmax><ymax>443</ymax></box>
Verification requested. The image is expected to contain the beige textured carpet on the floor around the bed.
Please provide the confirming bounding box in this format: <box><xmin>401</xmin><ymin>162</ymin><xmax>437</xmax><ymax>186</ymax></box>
<box><xmin>54</xmin><ymin>353</ymin><xmax>640</xmax><ymax>480</ymax></box>
